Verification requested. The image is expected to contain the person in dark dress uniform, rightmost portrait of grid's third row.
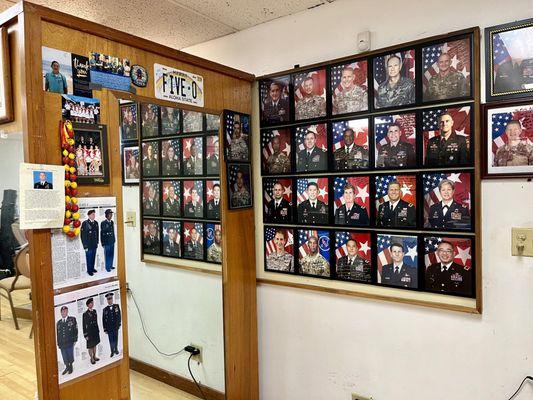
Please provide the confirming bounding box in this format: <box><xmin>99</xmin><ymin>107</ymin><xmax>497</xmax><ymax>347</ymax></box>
<box><xmin>428</xmin><ymin>179</ymin><xmax>470</xmax><ymax>229</ymax></box>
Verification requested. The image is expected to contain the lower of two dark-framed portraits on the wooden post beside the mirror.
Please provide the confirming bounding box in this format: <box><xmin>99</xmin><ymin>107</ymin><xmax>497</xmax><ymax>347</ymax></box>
<box><xmin>227</xmin><ymin>163</ymin><xmax>253</xmax><ymax>210</ymax></box>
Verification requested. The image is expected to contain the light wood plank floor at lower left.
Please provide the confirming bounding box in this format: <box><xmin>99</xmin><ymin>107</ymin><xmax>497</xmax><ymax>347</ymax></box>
<box><xmin>0</xmin><ymin>291</ymin><xmax>197</xmax><ymax>400</ymax></box>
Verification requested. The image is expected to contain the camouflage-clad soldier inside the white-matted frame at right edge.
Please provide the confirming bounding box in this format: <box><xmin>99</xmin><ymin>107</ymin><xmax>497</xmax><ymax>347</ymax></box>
<box><xmin>493</xmin><ymin>120</ymin><xmax>533</xmax><ymax>167</ymax></box>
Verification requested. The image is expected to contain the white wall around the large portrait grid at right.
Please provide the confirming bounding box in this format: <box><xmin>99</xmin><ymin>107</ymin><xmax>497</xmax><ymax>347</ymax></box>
<box><xmin>185</xmin><ymin>0</ymin><xmax>533</xmax><ymax>400</ymax></box>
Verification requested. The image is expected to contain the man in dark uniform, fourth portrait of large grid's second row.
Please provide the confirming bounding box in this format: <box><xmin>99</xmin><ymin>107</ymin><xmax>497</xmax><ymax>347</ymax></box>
<box><xmin>376</xmin><ymin>124</ymin><xmax>416</xmax><ymax>168</ymax></box>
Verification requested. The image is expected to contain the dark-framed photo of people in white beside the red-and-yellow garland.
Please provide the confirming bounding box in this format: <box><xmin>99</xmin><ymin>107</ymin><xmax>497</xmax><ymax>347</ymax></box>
<box><xmin>72</xmin><ymin>123</ymin><xmax>109</xmax><ymax>185</ymax></box>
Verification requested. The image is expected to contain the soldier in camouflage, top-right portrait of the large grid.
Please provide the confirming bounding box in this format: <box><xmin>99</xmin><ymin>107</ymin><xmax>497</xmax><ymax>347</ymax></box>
<box><xmin>424</xmin><ymin>53</ymin><xmax>468</xmax><ymax>101</ymax></box>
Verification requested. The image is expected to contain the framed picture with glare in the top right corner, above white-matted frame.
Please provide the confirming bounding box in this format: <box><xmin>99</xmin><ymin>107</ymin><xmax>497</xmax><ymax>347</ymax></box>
<box><xmin>485</xmin><ymin>18</ymin><xmax>533</xmax><ymax>101</ymax></box>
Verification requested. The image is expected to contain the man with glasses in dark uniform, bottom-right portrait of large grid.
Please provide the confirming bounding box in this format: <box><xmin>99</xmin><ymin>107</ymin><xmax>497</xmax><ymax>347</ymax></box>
<box><xmin>426</xmin><ymin>240</ymin><xmax>472</xmax><ymax>295</ymax></box>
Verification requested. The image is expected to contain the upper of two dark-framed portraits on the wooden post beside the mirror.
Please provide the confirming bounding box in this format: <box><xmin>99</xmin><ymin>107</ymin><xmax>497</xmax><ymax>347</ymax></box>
<box><xmin>224</xmin><ymin>110</ymin><xmax>251</xmax><ymax>162</ymax></box>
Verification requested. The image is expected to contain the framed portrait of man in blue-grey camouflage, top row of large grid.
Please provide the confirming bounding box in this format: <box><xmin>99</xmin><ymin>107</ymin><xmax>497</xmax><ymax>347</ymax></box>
<box><xmin>372</xmin><ymin>49</ymin><xmax>416</xmax><ymax>109</ymax></box>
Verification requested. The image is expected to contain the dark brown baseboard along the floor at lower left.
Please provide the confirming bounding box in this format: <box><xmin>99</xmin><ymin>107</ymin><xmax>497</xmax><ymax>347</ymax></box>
<box><xmin>130</xmin><ymin>358</ymin><xmax>226</xmax><ymax>400</ymax></box>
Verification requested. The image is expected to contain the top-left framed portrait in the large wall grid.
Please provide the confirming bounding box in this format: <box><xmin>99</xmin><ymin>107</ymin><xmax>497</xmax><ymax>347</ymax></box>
<box><xmin>259</xmin><ymin>75</ymin><xmax>291</xmax><ymax>126</ymax></box>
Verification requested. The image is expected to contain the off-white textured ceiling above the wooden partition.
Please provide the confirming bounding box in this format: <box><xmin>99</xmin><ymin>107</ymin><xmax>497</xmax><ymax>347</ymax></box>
<box><xmin>0</xmin><ymin>0</ymin><xmax>334</xmax><ymax>49</ymax></box>
